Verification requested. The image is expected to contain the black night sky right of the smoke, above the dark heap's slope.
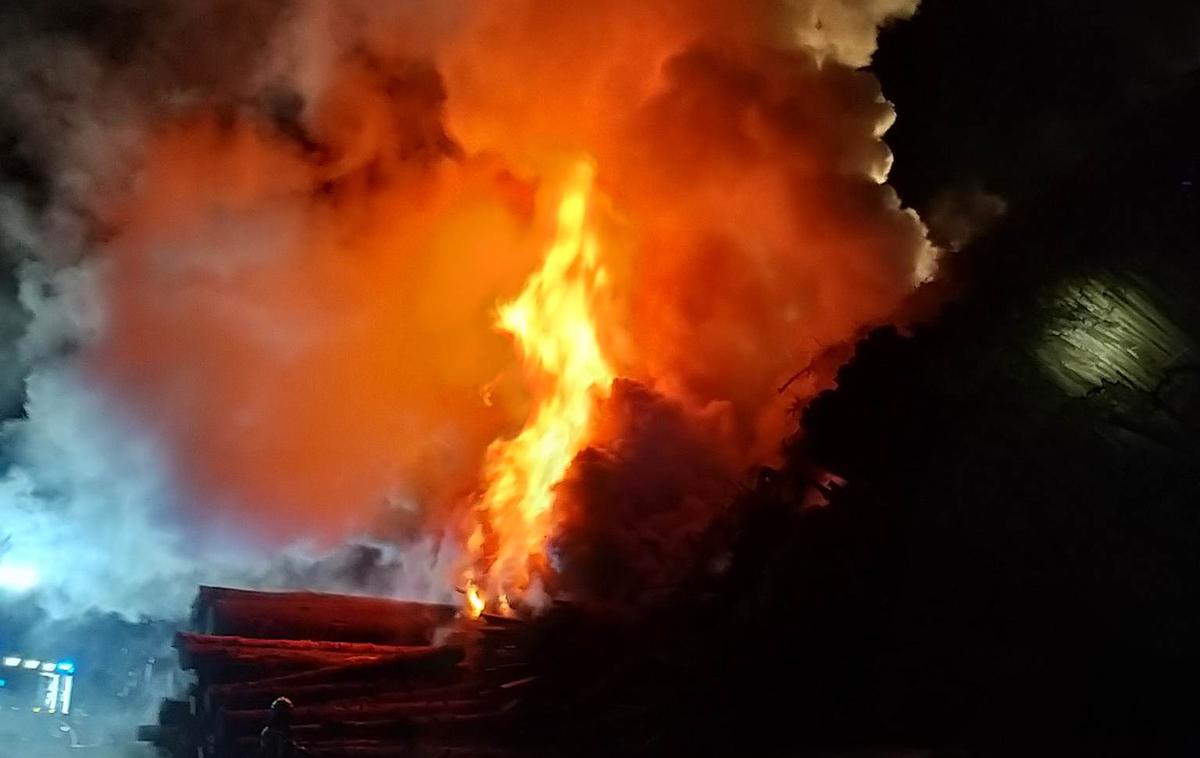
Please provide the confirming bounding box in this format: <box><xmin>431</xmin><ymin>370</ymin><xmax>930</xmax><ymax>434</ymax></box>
<box><xmin>875</xmin><ymin>0</ymin><xmax>1200</xmax><ymax>209</ymax></box>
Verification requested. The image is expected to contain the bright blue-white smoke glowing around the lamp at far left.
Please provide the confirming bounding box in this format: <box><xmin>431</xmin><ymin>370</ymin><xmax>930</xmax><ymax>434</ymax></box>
<box><xmin>0</xmin><ymin>367</ymin><xmax>200</xmax><ymax>618</ymax></box>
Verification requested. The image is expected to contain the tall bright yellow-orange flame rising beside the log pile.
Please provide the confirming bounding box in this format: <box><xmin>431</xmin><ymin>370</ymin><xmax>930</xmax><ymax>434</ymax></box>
<box><xmin>468</xmin><ymin>162</ymin><xmax>614</xmax><ymax>615</ymax></box>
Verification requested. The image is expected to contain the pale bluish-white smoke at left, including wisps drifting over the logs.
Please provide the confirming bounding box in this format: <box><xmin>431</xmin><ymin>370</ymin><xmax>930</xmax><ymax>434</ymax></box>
<box><xmin>0</xmin><ymin>257</ymin><xmax>456</xmax><ymax>619</ymax></box>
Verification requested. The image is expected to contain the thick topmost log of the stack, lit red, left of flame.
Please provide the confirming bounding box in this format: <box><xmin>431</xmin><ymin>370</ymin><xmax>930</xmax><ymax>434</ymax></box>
<box><xmin>192</xmin><ymin>586</ymin><xmax>458</xmax><ymax>645</ymax></box>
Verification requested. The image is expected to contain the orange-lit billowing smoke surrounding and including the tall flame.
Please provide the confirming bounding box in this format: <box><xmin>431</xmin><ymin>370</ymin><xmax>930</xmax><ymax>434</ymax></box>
<box><xmin>82</xmin><ymin>0</ymin><xmax>931</xmax><ymax>606</ymax></box>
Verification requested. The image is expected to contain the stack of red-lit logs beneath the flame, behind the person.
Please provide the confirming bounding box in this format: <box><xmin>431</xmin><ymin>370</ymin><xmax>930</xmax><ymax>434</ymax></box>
<box><xmin>139</xmin><ymin>586</ymin><xmax>549</xmax><ymax>758</ymax></box>
